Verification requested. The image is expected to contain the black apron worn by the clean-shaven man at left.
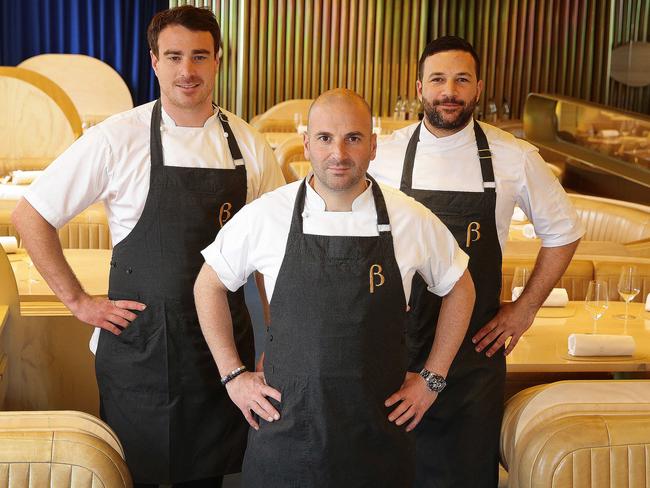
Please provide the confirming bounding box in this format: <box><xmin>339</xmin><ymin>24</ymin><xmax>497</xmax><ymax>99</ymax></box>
<box><xmin>95</xmin><ymin>100</ymin><xmax>254</xmax><ymax>483</ymax></box>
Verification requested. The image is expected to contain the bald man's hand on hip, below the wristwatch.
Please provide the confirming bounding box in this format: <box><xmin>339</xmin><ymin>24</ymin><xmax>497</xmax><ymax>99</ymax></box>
<box><xmin>384</xmin><ymin>373</ymin><xmax>438</xmax><ymax>432</ymax></box>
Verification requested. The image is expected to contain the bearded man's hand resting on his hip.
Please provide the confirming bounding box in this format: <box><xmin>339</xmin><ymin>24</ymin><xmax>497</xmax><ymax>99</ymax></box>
<box><xmin>472</xmin><ymin>302</ymin><xmax>535</xmax><ymax>357</ymax></box>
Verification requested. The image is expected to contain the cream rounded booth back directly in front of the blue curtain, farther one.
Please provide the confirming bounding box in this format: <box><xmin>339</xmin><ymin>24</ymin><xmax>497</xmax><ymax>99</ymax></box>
<box><xmin>18</xmin><ymin>54</ymin><xmax>133</xmax><ymax>125</ymax></box>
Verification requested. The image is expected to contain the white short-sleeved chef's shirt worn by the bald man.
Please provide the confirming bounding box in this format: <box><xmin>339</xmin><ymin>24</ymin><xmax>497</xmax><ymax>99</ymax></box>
<box><xmin>203</xmin><ymin>177</ymin><xmax>469</xmax><ymax>302</ymax></box>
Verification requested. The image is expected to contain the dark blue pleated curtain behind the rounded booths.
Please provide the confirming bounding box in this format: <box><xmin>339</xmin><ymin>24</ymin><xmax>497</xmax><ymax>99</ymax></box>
<box><xmin>0</xmin><ymin>0</ymin><xmax>169</xmax><ymax>105</ymax></box>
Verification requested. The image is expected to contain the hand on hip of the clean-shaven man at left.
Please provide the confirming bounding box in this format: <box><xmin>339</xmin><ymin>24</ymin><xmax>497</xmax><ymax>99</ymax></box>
<box><xmin>70</xmin><ymin>294</ymin><xmax>147</xmax><ymax>335</ymax></box>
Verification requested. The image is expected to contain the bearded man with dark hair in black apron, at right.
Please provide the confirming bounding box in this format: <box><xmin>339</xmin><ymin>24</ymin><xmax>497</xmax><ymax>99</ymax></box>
<box><xmin>369</xmin><ymin>36</ymin><xmax>583</xmax><ymax>488</ymax></box>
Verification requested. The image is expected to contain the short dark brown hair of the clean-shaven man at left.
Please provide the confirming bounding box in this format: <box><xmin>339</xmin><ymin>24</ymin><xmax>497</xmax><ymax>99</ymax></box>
<box><xmin>147</xmin><ymin>5</ymin><xmax>221</xmax><ymax>57</ymax></box>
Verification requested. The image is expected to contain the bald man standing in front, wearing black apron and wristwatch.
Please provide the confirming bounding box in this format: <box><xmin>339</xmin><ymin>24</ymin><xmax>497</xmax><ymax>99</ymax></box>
<box><xmin>194</xmin><ymin>90</ymin><xmax>474</xmax><ymax>488</ymax></box>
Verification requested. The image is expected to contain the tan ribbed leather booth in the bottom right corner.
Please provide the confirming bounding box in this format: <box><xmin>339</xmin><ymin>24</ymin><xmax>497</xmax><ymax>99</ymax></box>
<box><xmin>501</xmin><ymin>380</ymin><xmax>650</xmax><ymax>488</ymax></box>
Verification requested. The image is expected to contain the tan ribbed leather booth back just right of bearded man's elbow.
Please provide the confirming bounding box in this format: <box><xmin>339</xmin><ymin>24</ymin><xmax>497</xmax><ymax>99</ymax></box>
<box><xmin>569</xmin><ymin>194</ymin><xmax>650</xmax><ymax>243</ymax></box>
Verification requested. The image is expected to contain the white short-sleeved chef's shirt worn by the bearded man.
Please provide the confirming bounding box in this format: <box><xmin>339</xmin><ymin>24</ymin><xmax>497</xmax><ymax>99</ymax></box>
<box><xmin>368</xmin><ymin>121</ymin><xmax>584</xmax><ymax>251</ymax></box>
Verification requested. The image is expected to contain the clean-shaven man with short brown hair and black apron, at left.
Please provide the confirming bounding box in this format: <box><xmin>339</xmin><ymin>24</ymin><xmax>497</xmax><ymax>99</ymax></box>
<box><xmin>13</xmin><ymin>6</ymin><xmax>284</xmax><ymax>487</ymax></box>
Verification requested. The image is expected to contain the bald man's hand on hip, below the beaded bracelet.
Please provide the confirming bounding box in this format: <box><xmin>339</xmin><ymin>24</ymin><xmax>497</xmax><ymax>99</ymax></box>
<box><xmin>226</xmin><ymin>372</ymin><xmax>282</xmax><ymax>430</ymax></box>
